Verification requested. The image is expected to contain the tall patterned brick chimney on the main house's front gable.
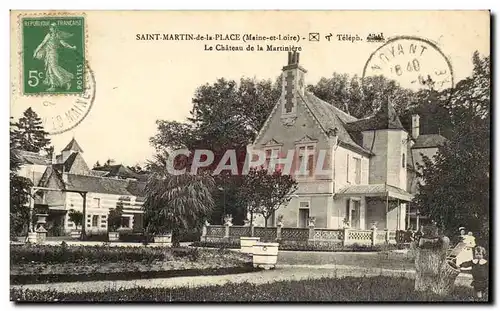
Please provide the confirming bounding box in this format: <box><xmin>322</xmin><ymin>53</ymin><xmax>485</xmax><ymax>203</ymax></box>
<box><xmin>281</xmin><ymin>52</ymin><xmax>307</xmax><ymax>116</ymax></box>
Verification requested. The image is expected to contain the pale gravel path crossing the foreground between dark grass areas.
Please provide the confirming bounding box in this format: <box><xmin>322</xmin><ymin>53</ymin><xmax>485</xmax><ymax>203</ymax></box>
<box><xmin>10</xmin><ymin>265</ymin><xmax>472</xmax><ymax>292</ymax></box>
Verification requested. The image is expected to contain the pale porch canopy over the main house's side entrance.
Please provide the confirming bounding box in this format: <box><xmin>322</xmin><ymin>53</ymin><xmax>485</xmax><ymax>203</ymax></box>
<box><xmin>335</xmin><ymin>184</ymin><xmax>413</xmax><ymax>202</ymax></box>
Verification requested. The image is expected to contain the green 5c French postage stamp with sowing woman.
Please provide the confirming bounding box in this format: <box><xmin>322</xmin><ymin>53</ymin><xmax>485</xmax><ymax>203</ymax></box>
<box><xmin>21</xmin><ymin>16</ymin><xmax>85</xmax><ymax>95</ymax></box>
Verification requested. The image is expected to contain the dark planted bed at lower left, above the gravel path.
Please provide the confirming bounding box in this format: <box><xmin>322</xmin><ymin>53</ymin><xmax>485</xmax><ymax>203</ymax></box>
<box><xmin>10</xmin><ymin>245</ymin><xmax>255</xmax><ymax>285</ymax></box>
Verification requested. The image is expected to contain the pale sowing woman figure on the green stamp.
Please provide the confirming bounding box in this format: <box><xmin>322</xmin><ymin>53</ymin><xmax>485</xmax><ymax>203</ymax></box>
<box><xmin>33</xmin><ymin>23</ymin><xmax>76</xmax><ymax>91</ymax></box>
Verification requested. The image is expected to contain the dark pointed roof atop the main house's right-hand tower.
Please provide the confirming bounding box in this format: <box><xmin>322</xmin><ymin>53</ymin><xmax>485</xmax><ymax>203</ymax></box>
<box><xmin>347</xmin><ymin>101</ymin><xmax>405</xmax><ymax>132</ymax></box>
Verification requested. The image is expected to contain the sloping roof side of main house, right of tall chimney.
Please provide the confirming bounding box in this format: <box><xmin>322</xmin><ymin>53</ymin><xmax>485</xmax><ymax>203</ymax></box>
<box><xmin>301</xmin><ymin>92</ymin><xmax>371</xmax><ymax>154</ymax></box>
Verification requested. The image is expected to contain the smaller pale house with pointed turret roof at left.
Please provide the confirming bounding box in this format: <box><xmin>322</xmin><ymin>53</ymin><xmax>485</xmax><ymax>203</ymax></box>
<box><xmin>19</xmin><ymin>138</ymin><xmax>145</xmax><ymax>235</ymax></box>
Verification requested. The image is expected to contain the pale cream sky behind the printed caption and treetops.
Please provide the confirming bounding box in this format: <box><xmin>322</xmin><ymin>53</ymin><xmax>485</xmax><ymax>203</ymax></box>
<box><xmin>11</xmin><ymin>11</ymin><xmax>490</xmax><ymax>165</ymax></box>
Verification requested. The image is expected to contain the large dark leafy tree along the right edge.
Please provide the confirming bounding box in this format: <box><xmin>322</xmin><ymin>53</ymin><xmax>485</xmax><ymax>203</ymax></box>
<box><xmin>415</xmin><ymin>53</ymin><xmax>490</xmax><ymax>242</ymax></box>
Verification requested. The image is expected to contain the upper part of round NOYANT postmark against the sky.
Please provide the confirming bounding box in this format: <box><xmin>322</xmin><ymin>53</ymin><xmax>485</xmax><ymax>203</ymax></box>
<box><xmin>363</xmin><ymin>36</ymin><xmax>454</xmax><ymax>94</ymax></box>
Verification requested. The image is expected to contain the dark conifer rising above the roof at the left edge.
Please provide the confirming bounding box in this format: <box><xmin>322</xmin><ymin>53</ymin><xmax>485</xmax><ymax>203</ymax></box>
<box><xmin>11</xmin><ymin>107</ymin><xmax>53</xmax><ymax>153</ymax></box>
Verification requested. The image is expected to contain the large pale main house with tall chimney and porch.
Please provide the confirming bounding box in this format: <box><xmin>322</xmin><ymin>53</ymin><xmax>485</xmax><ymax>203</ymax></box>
<box><xmin>248</xmin><ymin>52</ymin><xmax>445</xmax><ymax>230</ymax></box>
